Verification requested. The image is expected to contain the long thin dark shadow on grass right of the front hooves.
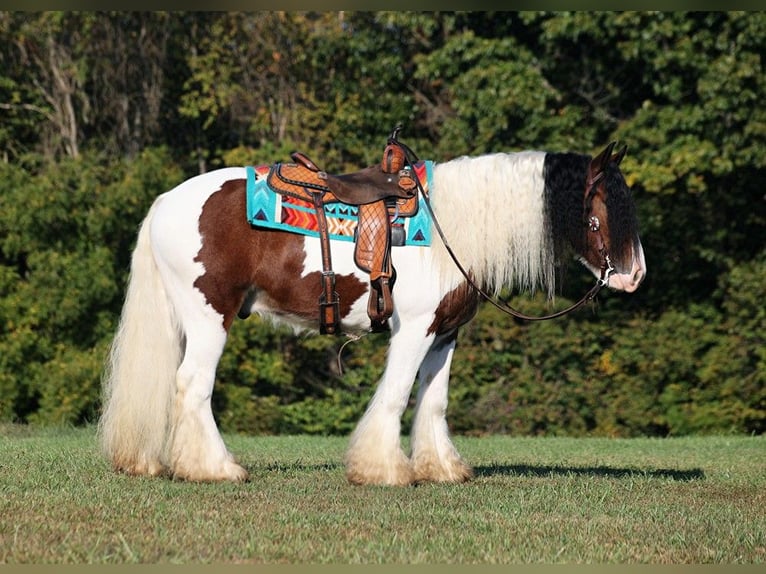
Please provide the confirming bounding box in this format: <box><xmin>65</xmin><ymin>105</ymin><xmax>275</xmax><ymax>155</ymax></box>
<box><xmin>474</xmin><ymin>464</ymin><xmax>705</xmax><ymax>482</ymax></box>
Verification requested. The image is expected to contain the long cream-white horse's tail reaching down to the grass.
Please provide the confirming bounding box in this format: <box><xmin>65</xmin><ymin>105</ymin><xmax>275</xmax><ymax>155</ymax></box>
<box><xmin>99</xmin><ymin>200</ymin><xmax>182</xmax><ymax>475</ymax></box>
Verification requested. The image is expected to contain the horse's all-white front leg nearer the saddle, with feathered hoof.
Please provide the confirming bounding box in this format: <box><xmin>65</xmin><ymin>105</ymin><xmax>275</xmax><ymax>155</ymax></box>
<box><xmin>346</xmin><ymin>317</ymin><xmax>434</xmax><ymax>486</ymax></box>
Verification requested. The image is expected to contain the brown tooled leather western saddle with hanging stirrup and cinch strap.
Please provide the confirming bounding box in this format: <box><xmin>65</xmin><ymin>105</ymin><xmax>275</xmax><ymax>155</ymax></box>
<box><xmin>266</xmin><ymin>125</ymin><xmax>419</xmax><ymax>334</ymax></box>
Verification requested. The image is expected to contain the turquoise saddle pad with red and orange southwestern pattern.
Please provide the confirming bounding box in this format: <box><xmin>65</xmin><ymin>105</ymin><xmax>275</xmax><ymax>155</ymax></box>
<box><xmin>245</xmin><ymin>161</ymin><xmax>433</xmax><ymax>247</ymax></box>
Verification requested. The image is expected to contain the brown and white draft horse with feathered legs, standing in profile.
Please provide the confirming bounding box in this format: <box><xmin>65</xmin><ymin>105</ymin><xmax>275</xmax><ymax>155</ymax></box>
<box><xmin>98</xmin><ymin>142</ymin><xmax>646</xmax><ymax>486</ymax></box>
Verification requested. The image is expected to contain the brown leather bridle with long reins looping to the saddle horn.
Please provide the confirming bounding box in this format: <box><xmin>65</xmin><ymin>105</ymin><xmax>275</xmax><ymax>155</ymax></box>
<box><xmin>388</xmin><ymin>125</ymin><xmax>614</xmax><ymax>321</ymax></box>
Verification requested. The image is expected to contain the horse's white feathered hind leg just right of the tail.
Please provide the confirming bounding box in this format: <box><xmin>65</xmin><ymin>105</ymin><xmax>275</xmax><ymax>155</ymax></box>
<box><xmin>170</xmin><ymin>316</ymin><xmax>247</xmax><ymax>481</ymax></box>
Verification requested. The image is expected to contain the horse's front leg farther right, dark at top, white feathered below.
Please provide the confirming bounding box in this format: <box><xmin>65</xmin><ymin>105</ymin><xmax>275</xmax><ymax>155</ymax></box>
<box><xmin>412</xmin><ymin>331</ymin><xmax>473</xmax><ymax>482</ymax></box>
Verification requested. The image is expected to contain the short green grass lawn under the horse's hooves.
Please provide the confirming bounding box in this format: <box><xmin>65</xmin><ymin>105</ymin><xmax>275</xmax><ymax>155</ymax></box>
<box><xmin>0</xmin><ymin>426</ymin><xmax>766</xmax><ymax>564</ymax></box>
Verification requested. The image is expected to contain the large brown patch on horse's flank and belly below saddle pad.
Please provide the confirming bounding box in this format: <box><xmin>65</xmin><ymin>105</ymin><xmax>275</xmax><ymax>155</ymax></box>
<box><xmin>194</xmin><ymin>179</ymin><xmax>368</xmax><ymax>331</ymax></box>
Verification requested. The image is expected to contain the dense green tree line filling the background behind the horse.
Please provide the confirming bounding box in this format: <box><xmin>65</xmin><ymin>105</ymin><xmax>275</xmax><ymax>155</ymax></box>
<box><xmin>0</xmin><ymin>12</ymin><xmax>766</xmax><ymax>436</ymax></box>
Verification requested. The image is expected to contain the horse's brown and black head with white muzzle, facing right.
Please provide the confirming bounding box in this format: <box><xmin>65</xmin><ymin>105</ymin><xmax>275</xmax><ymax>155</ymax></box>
<box><xmin>579</xmin><ymin>142</ymin><xmax>646</xmax><ymax>293</ymax></box>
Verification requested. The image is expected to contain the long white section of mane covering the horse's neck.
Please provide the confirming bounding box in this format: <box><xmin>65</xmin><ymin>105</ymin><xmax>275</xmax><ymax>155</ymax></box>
<box><xmin>430</xmin><ymin>151</ymin><xmax>555</xmax><ymax>297</ymax></box>
